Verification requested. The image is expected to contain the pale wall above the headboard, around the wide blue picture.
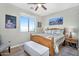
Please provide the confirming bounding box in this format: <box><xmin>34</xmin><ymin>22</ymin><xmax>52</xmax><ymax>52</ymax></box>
<box><xmin>41</xmin><ymin>6</ymin><xmax>79</xmax><ymax>28</ymax></box>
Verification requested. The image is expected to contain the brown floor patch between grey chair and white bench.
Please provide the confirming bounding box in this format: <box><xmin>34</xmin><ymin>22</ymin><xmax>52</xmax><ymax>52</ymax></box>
<box><xmin>1</xmin><ymin>46</ymin><xmax>28</xmax><ymax>56</ymax></box>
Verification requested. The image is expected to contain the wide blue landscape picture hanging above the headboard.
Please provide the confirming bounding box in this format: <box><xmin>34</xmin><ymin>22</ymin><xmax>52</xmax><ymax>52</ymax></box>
<box><xmin>49</xmin><ymin>17</ymin><xmax>63</xmax><ymax>25</ymax></box>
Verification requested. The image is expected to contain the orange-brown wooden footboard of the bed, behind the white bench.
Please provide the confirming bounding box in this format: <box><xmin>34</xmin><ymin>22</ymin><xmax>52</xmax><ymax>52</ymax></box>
<box><xmin>31</xmin><ymin>35</ymin><xmax>54</xmax><ymax>56</ymax></box>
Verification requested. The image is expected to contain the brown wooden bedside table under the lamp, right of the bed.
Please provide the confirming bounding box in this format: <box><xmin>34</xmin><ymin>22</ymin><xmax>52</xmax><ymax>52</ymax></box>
<box><xmin>65</xmin><ymin>37</ymin><xmax>78</xmax><ymax>48</ymax></box>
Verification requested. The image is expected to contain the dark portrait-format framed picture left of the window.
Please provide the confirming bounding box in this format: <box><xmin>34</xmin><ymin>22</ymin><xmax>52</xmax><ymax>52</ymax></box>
<box><xmin>5</xmin><ymin>15</ymin><xmax>16</xmax><ymax>29</ymax></box>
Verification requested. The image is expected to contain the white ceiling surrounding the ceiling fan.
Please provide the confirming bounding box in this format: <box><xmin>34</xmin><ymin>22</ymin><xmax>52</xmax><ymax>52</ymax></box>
<box><xmin>11</xmin><ymin>3</ymin><xmax>79</xmax><ymax>16</ymax></box>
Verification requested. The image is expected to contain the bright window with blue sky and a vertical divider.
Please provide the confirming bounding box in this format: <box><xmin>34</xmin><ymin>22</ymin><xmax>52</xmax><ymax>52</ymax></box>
<box><xmin>20</xmin><ymin>16</ymin><xmax>35</xmax><ymax>32</ymax></box>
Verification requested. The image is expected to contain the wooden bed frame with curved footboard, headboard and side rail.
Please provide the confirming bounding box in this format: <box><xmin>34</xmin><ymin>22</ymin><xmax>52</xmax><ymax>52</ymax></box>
<box><xmin>31</xmin><ymin>28</ymin><xmax>65</xmax><ymax>56</ymax></box>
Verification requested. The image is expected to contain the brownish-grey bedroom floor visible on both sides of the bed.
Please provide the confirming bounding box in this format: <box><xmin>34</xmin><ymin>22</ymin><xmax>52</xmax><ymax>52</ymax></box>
<box><xmin>2</xmin><ymin>46</ymin><xmax>77</xmax><ymax>56</ymax></box>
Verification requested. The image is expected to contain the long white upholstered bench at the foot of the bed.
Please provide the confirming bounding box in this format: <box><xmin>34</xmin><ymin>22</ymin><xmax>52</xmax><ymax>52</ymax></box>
<box><xmin>24</xmin><ymin>41</ymin><xmax>49</xmax><ymax>56</ymax></box>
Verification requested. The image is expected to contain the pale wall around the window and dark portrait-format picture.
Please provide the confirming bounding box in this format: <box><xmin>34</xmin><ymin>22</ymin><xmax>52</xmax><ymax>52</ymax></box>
<box><xmin>0</xmin><ymin>4</ymin><xmax>38</xmax><ymax>46</ymax></box>
